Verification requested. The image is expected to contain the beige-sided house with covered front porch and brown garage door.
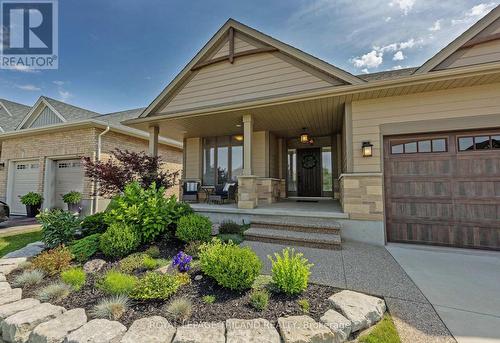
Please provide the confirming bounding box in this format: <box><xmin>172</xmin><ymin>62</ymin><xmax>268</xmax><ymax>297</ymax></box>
<box><xmin>125</xmin><ymin>7</ymin><xmax>500</xmax><ymax>249</ymax></box>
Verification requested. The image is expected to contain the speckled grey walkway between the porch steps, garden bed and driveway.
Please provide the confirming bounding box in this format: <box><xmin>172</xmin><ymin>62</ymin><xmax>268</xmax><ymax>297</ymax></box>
<box><xmin>243</xmin><ymin>241</ymin><xmax>455</xmax><ymax>343</ymax></box>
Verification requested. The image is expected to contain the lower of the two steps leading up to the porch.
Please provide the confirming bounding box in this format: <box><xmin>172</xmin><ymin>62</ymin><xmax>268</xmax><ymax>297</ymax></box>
<box><xmin>244</xmin><ymin>226</ymin><xmax>341</xmax><ymax>249</ymax></box>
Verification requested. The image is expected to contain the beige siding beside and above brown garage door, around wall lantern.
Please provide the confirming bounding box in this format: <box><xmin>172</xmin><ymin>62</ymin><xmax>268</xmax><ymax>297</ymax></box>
<box><xmin>352</xmin><ymin>83</ymin><xmax>500</xmax><ymax>172</ymax></box>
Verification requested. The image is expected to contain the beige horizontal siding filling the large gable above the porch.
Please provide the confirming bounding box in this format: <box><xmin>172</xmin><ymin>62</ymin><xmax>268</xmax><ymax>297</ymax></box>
<box><xmin>160</xmin><ymin>52</ymin><xmax>340</xmax><ymax>113</ymax></box>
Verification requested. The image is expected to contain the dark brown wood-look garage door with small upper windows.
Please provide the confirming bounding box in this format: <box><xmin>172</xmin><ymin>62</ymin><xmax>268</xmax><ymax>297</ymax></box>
<box><xmin>384</xmin><ymin>129</ymin><xmax>500</xmax><ymax>249</ymax></box>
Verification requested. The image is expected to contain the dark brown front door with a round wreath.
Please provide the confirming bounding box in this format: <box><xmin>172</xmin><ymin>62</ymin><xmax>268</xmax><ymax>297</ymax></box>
<box><xmin>297</xmin><ymin>148</ymin><xmax>321</xmax><ymax>197</ymax></box>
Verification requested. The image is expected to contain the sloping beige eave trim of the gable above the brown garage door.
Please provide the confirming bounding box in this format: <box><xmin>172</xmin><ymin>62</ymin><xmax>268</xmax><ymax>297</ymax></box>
<box><xmin>414</xmin><ymin>5</ymin><xmax>500</xmax><ymax>74</ymax></box>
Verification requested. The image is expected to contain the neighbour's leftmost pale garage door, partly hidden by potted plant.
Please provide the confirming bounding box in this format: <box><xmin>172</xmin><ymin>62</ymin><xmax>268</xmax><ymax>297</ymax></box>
<box><xmin>10</xmin><ymin>161</ymin><xmax>40</xmax><ymax>214</ymax></box>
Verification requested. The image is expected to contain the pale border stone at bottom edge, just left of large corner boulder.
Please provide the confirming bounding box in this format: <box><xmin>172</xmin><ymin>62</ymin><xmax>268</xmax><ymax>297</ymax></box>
<box><xmin>278</xmin><ymin>316</ymin><xmax>334</xmax><ymax>343</ymax></box>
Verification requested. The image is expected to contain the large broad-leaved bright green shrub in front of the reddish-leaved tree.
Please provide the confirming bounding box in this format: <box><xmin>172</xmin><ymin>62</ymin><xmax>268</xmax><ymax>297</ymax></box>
<box><xmin>105</xmin><ymin>182</ymin><xmax>177</xmax><ymax>243</ymax></box>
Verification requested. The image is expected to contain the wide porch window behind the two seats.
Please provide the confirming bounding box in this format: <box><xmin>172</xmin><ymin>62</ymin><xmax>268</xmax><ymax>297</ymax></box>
<box><xmin>203</xmin><ymin>136</ymin><xmax>243</xmax><ymax>186</ymax></box>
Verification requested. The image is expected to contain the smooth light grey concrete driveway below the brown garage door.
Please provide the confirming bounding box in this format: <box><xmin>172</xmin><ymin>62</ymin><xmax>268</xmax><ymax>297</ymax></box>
<box><xmin>386</xmin><ymin>244</ymin><xmax>500</xmax><ymax>343</ymax></box>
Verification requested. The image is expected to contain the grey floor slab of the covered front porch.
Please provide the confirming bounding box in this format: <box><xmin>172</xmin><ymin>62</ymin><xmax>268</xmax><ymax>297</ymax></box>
<box><xmin>191</xmin><ymin>198</ymin><xmax>349</xmax><ymax>219</ymax></box>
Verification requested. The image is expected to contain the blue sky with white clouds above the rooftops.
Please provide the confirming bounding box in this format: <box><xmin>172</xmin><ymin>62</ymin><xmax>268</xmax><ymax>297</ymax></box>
<box><xmin>0</xmin><ymin>0</ymin><xmax>499</xmax><ymax>113</ymax></box>
